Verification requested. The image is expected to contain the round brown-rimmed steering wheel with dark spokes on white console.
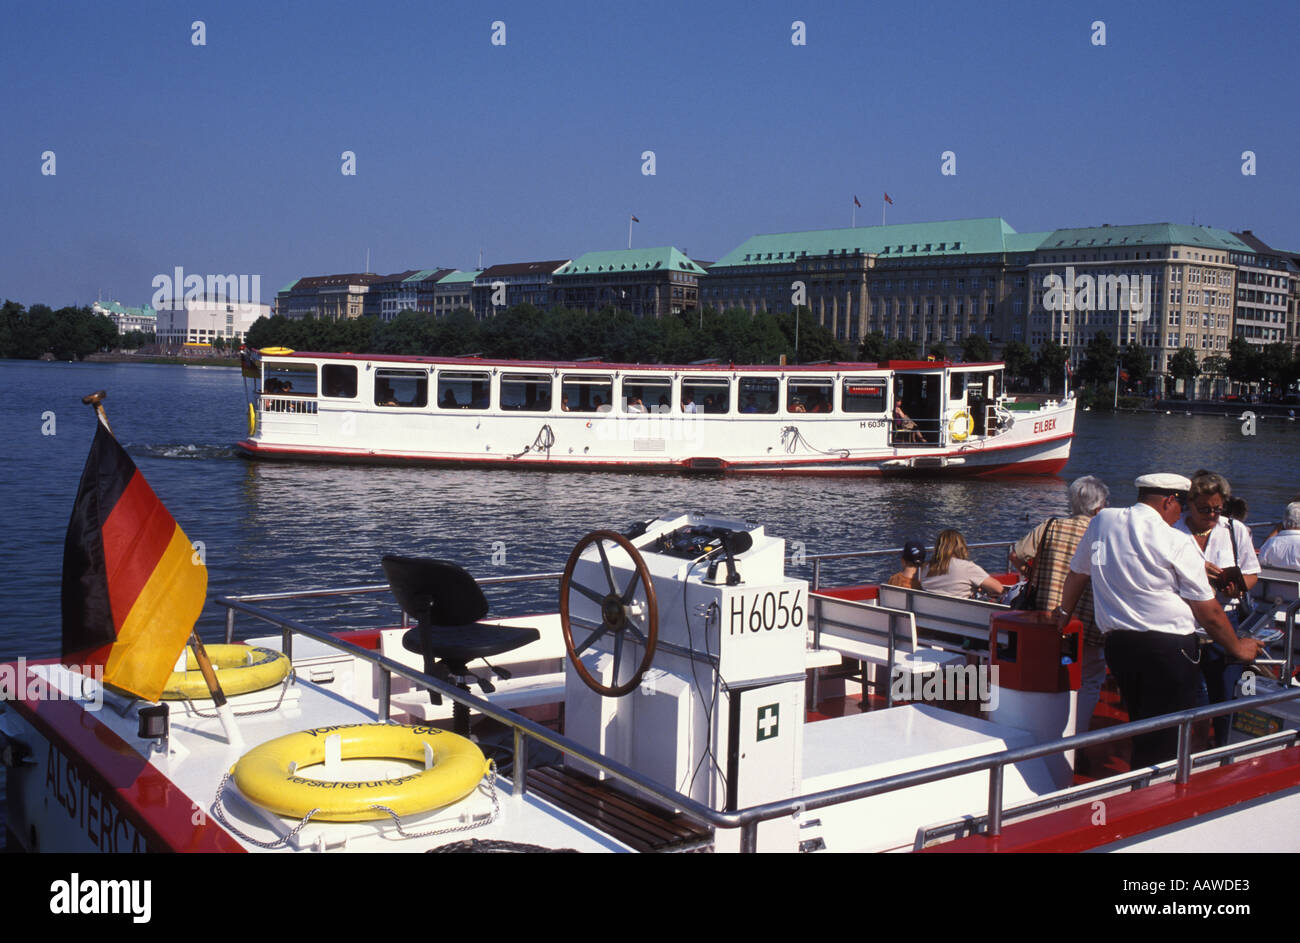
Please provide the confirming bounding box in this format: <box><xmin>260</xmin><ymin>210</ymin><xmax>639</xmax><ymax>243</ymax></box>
<box><xmin>560</xmin><ymin>531</ymin><xmax>659</xmax><ymax>697</ymax></box>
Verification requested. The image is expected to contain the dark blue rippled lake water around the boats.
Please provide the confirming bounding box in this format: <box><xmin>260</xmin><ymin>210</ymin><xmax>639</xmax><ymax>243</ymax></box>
<box><xmin>0</xmin><ymin>360</ymin><xmax>1300</xmax><ymax>825</ymax></box>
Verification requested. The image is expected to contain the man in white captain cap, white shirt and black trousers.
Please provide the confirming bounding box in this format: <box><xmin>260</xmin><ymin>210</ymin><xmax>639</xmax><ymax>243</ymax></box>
<box><xmin>1056</xmin><ymin>473</ymin><xmax>1262</xmax><ymax>769</ymax></box>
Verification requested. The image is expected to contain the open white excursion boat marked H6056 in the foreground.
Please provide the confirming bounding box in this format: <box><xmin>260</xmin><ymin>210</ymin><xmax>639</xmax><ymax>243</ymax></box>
<box><xmin>0</xmin><ymin>515</ymin><xmax>1300</xmax><ymax>852</ymax></box>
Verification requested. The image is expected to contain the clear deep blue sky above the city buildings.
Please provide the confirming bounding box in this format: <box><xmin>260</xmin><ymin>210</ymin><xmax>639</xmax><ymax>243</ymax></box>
<box><xmin>0</xmin><ymin>0</ymin><xmax>1300</xmax><ymax>306</ymax></box>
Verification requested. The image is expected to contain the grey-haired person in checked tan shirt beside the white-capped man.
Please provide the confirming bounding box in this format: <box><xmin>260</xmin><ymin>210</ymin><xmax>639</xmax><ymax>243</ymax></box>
<box><xmin>1010</xmin><ymin>475</ymin><xmax>1110</xmax><ymax>732</ymax></box>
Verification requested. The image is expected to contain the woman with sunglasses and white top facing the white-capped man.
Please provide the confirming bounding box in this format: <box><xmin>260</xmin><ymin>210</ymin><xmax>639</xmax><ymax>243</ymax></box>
<box><xmin>1174</xmin><ymin>470</ymin><xmax>1260</xmax><ymax>747</ymax></box>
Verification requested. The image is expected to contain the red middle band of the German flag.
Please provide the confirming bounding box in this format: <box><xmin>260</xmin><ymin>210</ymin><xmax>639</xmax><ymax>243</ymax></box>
<box><xmin>103</xmin><ymin>471</ymin><xmax>176</xmax><ymax>632</ymax></box>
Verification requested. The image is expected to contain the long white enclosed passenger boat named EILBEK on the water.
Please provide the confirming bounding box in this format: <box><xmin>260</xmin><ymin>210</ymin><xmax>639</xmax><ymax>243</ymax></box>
<box><xmin>238</xmin><ymin>349</ymin><xmax>1075</xmax><ymax>475</ymax></box>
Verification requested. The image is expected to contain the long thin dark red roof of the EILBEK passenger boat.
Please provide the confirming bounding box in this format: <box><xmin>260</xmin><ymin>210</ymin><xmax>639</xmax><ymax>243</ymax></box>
<box><xmin>259</xmin><ymin>350</ymin><xmax>1002</xmax><ymax>373</ymax></box>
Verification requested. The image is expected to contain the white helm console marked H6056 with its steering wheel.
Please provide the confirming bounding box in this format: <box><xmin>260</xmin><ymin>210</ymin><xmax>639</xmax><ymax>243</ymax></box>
<box><xmin>560</xmin><ymin>514</ymin><xmax>809</xmax><ymax>849</ymax></box>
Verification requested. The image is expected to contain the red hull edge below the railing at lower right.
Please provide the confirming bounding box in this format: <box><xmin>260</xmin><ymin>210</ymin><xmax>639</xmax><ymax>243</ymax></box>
<box><xmin>924</xmin><ymin>747</ymin><xmax>1300</xmax><ymax>853</ymax></box>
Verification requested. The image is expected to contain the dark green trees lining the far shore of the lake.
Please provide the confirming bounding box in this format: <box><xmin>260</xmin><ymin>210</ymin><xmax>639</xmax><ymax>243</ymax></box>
<box><xmin>10</xmin><ymin>293</ymin><xmax>1300</xmax><ymax>393</ymax></box>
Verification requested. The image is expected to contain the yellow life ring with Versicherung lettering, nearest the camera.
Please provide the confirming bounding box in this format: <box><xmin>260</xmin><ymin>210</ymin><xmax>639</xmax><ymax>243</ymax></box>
<box><xmin>230</xmin><ymin>723</ymin><xmax>489</xmax><ymax>822</ymax></box>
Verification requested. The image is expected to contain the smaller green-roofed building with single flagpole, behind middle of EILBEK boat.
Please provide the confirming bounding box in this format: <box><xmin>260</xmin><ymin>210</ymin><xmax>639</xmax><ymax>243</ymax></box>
<box><xmin>553</xmin><ymin>246</ymin><xmax>706</xmax><ymax>317</ymax></box>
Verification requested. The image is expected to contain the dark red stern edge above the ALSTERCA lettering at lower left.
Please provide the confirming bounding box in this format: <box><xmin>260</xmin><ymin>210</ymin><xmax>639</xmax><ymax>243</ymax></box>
<box><xmin>14</xmin><ymin>662</ymin><xmax>244</xmax><ymax>852</ymax></box>
